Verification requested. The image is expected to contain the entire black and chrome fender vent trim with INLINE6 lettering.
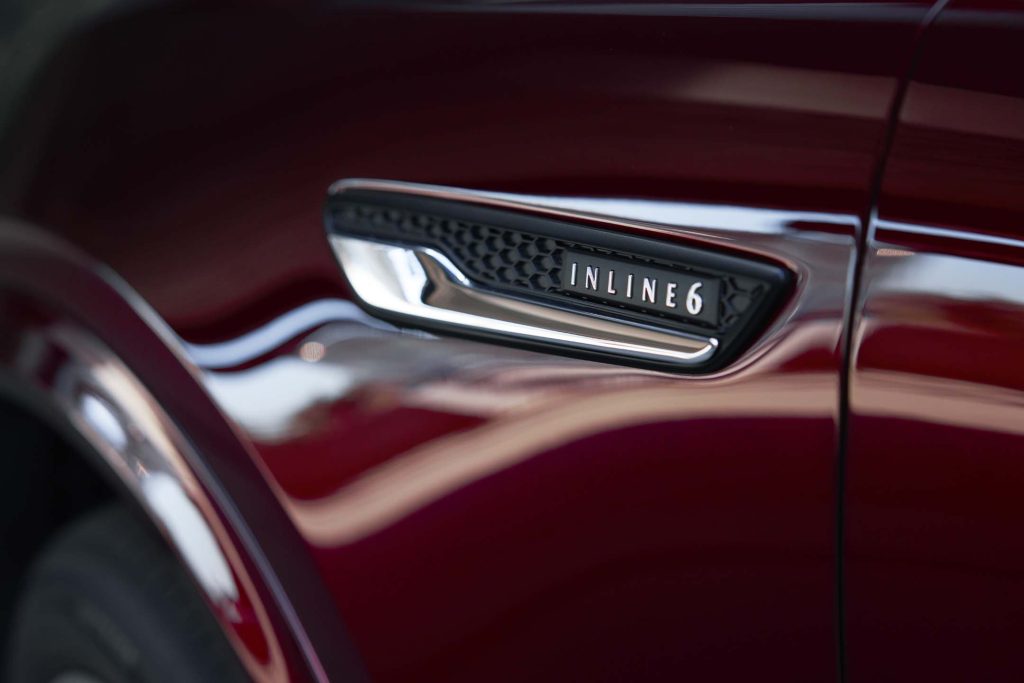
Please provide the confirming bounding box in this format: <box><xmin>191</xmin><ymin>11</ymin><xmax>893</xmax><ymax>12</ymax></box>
<box><xmin>326</xmin><ymin>181</ymin><xmax>791</xmax><ymax>373</ymax></box>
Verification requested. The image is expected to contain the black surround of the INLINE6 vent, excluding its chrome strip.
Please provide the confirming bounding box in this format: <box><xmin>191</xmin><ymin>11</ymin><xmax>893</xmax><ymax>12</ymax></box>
<box><xmin>325</xmin><ymin>189</ymin><xmax>792</xmax><ymax>372</ymax></box>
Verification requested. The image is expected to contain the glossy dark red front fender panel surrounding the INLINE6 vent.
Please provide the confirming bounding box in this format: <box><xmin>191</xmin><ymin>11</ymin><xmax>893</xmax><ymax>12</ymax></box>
<box><xmin>0</xmin><ymin>3</ymin><xmax>954</xmax><ymax>681</ymax></box>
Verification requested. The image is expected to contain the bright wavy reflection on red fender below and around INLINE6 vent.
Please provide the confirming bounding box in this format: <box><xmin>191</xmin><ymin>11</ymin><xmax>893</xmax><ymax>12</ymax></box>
<box><xmin>189</xmin><ymin>188</ymin><xmax>856</xmax><ymax>546</ymax></box>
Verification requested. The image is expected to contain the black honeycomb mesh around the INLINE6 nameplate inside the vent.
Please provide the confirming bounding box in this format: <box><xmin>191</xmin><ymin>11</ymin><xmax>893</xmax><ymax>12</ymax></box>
<box><xmin>332</xmin><ymin>202</ymin><xmax>765</xmax><ymax>331</ymax></box>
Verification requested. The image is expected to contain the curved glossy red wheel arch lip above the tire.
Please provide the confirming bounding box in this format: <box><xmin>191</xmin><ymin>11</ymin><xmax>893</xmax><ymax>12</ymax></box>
<box><xmin>0</xmin><ymin>219</ymin><xmax>361</xmax><ymax>681</ymax></box>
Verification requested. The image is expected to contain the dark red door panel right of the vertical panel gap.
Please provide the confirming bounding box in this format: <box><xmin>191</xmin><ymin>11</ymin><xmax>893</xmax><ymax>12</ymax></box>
<box><xmin>846</xmin><ymin>1</ymin><xmax>1024</xmax><ymax>681</ymax></box>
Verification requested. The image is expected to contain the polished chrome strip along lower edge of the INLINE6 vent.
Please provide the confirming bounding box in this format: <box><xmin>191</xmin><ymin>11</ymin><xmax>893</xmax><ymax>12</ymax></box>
<box><xmin>330</xmin><ymin>234</ymin><xmax>718</xmax><ymax>366</ymax></box>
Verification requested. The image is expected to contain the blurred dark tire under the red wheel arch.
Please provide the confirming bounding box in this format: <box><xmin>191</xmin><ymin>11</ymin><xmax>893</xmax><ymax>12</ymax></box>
<box><xmin>5</xmin><ymin>505</ymin><xmax>248</xmax><ymax>683</ymax></box>
